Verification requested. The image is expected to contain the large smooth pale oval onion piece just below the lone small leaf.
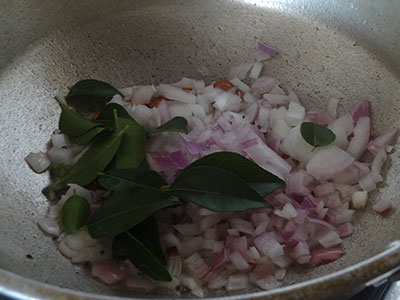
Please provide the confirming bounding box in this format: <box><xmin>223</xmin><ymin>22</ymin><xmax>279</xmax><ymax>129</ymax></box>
<box><xmin>306</xmin><ymin>146</ymin><xmax>354</xmax><ymax>180</ymax></box>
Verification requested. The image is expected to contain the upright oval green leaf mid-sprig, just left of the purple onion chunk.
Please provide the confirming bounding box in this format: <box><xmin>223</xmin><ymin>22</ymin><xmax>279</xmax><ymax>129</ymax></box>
<box><xmin>114</xmin><ymin>118</ymin><xmax>146</xmax><ymax>169</ymax></box>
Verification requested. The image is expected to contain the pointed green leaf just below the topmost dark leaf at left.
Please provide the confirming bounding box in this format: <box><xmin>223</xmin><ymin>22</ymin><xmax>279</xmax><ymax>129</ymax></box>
<box><xmin>58</xmin><ymin>102</ymin><xmax>99</xmax><ymax>137</ymax></box>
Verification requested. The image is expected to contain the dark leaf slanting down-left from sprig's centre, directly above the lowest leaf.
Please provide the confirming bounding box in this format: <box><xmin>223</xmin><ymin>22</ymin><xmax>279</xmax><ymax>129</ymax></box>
<box><xmin>87</xmin><ymin>187</ymin><xmax>180</xmax><ymax>238</ymax></box>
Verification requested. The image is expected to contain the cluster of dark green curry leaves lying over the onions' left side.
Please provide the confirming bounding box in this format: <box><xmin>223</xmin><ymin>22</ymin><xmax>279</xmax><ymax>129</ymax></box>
<box><xmin>51</xmin><ymin>80</ymin><xmax>285</xmax><ymax>281</ymax></box>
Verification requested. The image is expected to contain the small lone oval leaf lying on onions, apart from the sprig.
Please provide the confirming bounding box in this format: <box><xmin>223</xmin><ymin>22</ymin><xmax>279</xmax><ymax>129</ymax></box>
<box><xmin>300</xmin><ymin>122</ymin><xmax>336</xmax><ymax>148</ymax></box>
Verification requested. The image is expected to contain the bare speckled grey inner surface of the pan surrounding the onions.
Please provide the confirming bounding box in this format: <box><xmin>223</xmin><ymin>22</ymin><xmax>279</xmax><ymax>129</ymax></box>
<box><xmin>0</xmin><ymin>0</ymin><xmax>400</xmax><ymax>296</ymax></box>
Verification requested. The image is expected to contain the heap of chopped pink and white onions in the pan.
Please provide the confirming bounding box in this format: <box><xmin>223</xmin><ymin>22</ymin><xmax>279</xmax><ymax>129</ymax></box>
<box><xmin>29</xmin><ymin>43</ymin><xmax>397</xmax><ymax>297</ymax></box>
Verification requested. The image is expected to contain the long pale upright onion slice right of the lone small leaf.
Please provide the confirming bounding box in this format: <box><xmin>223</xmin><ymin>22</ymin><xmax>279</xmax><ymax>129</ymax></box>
<box><xmin>347</xmin><ymin>117</ymin><xmax>370</xmax><ymax>159</ymax></box>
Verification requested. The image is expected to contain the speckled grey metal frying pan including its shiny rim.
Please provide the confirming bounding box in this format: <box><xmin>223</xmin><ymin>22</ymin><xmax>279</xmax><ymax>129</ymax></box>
<box><xmin>0</xmin><ymin>0</ymin><xmax>400</xmax><ymax>299</ymax></box>
